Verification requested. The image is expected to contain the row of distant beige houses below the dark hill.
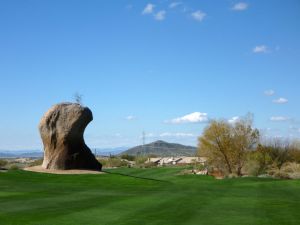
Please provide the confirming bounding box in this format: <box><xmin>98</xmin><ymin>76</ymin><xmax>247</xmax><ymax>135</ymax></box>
<box><xmin>147</xmin><ymin>156</ymin><xmax>206</xmax><ymax>166</ymax></box>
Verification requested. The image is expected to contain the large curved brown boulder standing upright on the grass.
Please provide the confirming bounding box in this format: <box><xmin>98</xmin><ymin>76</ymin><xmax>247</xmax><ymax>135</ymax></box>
<box><xmin>39</xmin><ymin>103</ymin><xmax>102</xmax><ymax>170</ymax></box>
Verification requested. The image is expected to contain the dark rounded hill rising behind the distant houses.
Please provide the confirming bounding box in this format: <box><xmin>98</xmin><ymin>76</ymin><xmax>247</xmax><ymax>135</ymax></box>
<box><xmin>121</xmin><ymin>141</ymin><xmax>197</xmax><ymax>157</ymax></box>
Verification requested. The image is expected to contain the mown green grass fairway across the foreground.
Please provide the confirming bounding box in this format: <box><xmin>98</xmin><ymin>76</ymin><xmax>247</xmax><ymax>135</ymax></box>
<box><xmin>0</xmin><ymin>168</ymin><xmax>300</xmax><ymax>225</ymax></box>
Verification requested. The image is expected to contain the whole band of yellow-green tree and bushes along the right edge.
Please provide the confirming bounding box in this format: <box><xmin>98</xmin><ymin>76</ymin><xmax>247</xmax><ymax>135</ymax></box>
<box><xmin>197</xmin><ymin>114</ymin><xmax>300</xmax><ymax>177</ymax></box>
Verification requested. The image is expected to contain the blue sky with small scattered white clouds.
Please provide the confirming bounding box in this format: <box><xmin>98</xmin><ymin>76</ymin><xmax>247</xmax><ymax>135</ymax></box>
<box><xmin>0</xmin><ymin>0</ymin><xmax>300</xmax><ymax>150</ymax></box>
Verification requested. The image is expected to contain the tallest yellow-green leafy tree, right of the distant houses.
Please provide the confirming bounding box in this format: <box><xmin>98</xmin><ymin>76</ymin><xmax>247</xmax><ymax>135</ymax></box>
<box><xmin>198</xmin><ymin>116</ymin><xmax>259</xmax><ymax>176</ymax></box>
